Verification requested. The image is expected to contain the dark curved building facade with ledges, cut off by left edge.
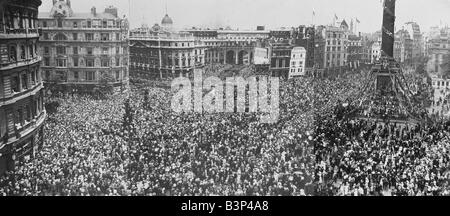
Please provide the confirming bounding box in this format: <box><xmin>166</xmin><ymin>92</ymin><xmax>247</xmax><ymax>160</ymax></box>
<box><xmin>0</xmin><ymin>0</ymin><xmax>46</xmax><ymax>175</ymax></box>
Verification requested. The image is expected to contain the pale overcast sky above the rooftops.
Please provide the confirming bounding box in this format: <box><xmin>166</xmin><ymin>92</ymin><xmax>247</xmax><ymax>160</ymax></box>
<box><xmin>39</xmin><ymin>0</ymin><xmax>450</xmax><ymax>32</ymax></box>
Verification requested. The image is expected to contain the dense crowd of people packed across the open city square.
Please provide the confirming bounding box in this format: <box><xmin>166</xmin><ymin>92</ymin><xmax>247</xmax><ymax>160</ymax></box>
<box><xmin>0</xmin><ymin>65</ymin><xmax>450</xmax><ymax>196</ymax></box>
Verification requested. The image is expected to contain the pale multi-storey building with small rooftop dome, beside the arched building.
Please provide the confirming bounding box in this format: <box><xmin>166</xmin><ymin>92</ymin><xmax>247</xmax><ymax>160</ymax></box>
<box><xmin>130</xmin><ymin>19</ymin><xmax>206</xmax><ymax>79</ymax></box>
